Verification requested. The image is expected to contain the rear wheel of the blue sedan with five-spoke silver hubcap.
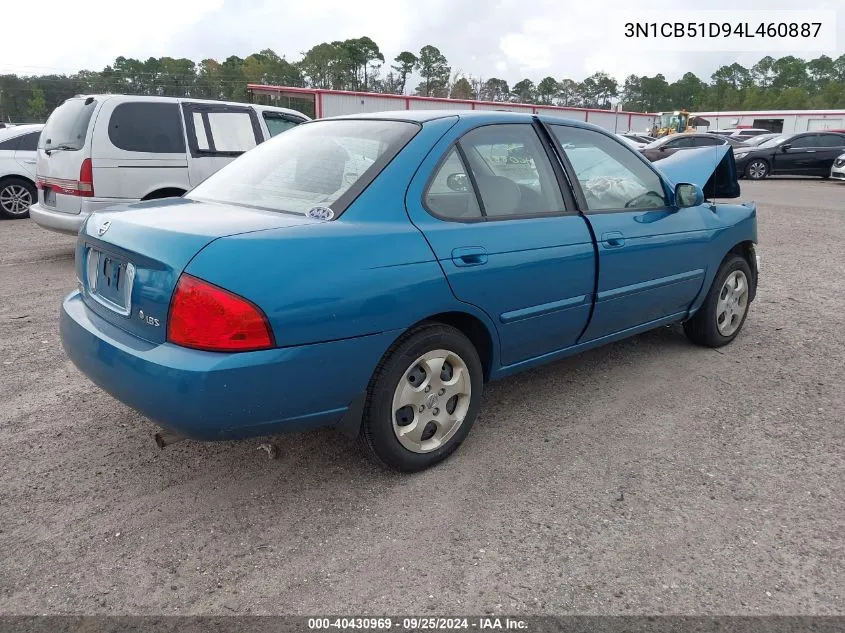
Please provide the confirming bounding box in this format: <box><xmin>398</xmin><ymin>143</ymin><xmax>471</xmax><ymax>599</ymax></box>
<box><xmin>359</xmin><ymin>323</ymin><xmax>484</xmax><ymax>472</ymax></box>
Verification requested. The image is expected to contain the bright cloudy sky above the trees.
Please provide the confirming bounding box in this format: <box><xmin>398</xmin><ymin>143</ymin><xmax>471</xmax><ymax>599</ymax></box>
<box><xmin>0</xmin><ymin>0</ymin><xmax>845</xmax><ymax>83</ymax></box>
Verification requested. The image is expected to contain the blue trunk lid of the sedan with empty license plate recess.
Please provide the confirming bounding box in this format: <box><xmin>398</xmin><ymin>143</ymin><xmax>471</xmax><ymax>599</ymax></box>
<box><xmin>76</xmin><ymin>198</ymin><xmax>319</xmax><ymax>343</ymax></box>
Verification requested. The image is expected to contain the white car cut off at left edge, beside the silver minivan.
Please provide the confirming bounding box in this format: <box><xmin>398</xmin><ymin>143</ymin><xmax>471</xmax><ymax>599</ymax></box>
<box><xmin>0</xmin><ymin>124</ymin><xmax>44</xmax><ymax>219</ymax></box>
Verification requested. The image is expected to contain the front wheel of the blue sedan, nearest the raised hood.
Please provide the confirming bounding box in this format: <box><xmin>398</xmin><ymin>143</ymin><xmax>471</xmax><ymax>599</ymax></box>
<box><xmin>684</xmin><ymin>254</ymin><xmax>752</xmax><ymax>347</ymax></box>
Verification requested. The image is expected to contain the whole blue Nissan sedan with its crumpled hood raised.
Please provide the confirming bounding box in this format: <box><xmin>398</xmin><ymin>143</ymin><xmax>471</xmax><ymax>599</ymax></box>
<box><xmin>61</xmin><ymin>111</ymin><xmax>757</xmax><ymax>471</ymax></box>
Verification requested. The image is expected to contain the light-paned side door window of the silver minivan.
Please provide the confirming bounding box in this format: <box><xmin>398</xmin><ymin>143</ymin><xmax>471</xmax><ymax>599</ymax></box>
<box><xmin>184</xmin><ymin>103</ymin><xmax>263</xmax><ymax>156</ymax></box>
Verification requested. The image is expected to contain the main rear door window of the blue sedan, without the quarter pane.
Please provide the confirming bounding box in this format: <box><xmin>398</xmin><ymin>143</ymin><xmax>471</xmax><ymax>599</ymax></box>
<box><xmin>459</xmin><ymin>124</ymin><xmax>565</xmax><ymax>217</ymax></box>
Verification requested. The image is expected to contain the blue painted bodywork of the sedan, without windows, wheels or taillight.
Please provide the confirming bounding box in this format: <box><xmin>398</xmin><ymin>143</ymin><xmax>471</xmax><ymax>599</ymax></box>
<box><xmin>61</xmin><ymin>112</ymin><xmax>757</xmax><ymax>440</ymax></box>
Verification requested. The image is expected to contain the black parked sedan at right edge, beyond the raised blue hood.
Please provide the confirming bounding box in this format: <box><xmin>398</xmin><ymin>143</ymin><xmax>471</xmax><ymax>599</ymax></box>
<box><xmin>734</xmin><ymin>132</ymin><xmax>845</xmax><ymax>180</ymax></box>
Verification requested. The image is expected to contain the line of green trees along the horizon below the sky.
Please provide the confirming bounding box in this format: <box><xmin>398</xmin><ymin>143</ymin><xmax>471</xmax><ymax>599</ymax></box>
<box><xmin>0</xmin><ymin>37</ymin><xmax>845</xmax><ymax>122</ymax></box>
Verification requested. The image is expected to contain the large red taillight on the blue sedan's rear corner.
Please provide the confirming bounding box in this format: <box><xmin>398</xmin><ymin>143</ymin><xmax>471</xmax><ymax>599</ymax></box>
<box><xmin>167</xmin><ymin>274</ymin><xmax>275</xmax><ymax>352</ymax></box>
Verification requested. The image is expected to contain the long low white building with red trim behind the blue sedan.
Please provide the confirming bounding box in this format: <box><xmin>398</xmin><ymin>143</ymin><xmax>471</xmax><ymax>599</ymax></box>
<box><xmin>247</xmin><ymin>84</ymin><xmax>654</xmax><ymax>132</ymax></box>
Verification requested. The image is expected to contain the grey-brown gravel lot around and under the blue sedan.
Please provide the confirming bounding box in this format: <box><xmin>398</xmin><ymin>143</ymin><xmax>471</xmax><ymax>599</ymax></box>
<box><xmin>0</xmin><ymin>179</ymin><xmax>845</xmax><ymax>615</ymax></box>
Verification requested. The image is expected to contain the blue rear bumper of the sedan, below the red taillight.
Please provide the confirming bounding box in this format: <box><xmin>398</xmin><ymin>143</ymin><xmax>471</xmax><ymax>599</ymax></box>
<box><xmin>60</xmin><ymin>292</ymin><xmax>398</xmax><ymax>440</ymax></box>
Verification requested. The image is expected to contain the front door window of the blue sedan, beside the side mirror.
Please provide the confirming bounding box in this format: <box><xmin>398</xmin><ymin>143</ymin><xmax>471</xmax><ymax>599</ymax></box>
<box><xmin>552</xmin><ymin>125</ymin><xmax>666</xmax><ymax>211</ymax></box>
